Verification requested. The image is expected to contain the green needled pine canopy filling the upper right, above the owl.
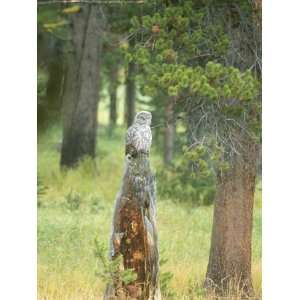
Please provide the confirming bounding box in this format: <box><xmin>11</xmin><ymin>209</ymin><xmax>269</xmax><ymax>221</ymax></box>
<box><xmin>130</xmin><ymin>1</ymin><xmax>261</xmax><ymax>163</ymax></box>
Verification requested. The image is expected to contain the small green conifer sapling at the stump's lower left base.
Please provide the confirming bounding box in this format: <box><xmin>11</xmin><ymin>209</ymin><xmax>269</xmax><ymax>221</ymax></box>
<box><xmin>94</xmin><ymin>239</ymin><xmax>137</xmax><ymax>284</ymax></box>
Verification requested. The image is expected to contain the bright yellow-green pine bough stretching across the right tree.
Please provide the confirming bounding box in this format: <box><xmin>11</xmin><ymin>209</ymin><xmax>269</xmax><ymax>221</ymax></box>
<box><xmin>137</xmin><ymin>59</ymin><xmax>260</xmax><ymax>104</ymax></box>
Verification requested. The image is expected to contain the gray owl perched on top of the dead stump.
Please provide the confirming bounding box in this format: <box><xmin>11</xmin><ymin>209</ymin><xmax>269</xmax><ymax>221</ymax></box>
<box><xmin>125</xmin><ymin>111</ymin><xmax>152</xmax><ymax>158</ymax></box>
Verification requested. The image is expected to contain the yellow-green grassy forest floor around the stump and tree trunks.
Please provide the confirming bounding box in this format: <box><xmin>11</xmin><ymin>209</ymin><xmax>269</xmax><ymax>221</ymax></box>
<box><xmin>38</xmin><ymin>123</ymin><xmax>261</xmax><ymax>300</ymax></box>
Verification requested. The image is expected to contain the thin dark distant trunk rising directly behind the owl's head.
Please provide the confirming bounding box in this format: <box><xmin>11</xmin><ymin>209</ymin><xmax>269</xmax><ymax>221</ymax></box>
<box><xmin>125</xmin><ymin>40</ymin><xmax>136</xmax><ymax>127</ymax></box>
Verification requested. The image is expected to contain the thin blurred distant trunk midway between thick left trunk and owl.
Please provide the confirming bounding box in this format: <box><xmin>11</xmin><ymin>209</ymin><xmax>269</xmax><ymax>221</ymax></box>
<box><xmin>109</xmin><ymin>65</ymin><xmax>118</xmax><ymax>131</ymax></box>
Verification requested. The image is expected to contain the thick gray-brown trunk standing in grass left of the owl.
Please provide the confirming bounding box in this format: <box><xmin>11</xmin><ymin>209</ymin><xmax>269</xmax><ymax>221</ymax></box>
<box><xmin>60</xmin><ymin>4</ymin><xmax>102</xmax><ymax>167</ymax></box>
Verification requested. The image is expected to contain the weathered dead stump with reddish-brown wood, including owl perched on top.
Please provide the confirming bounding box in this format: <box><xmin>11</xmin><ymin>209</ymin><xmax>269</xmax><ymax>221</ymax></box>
<box><xmin>104</xmin><ymin>112</ymin><xmax>161</xmax><ymax>300</ymax></box>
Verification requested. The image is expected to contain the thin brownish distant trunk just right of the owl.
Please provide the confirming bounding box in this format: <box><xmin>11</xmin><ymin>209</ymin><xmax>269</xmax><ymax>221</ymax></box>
<box><xmin>164</xmin><ymin>97</ymin><xmax>176</xmax><ymax>165</ymax></box>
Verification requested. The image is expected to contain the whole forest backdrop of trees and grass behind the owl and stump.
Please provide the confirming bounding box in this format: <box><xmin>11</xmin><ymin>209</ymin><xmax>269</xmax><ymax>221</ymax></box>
<box><xmin>37</xmin><ymin>0</ymin><xmax>261</xmax><ymax>299</ymax></box>
